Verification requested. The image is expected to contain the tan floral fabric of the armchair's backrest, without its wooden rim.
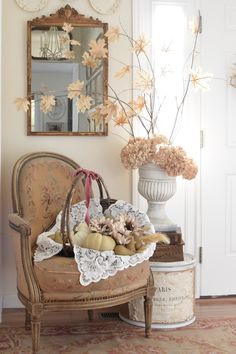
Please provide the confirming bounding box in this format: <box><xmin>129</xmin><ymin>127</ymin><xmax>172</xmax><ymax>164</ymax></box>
<box><xmin>19</xmin><ymin>157</ymin><xmax>85</xmax><ymax>245</ymax></box>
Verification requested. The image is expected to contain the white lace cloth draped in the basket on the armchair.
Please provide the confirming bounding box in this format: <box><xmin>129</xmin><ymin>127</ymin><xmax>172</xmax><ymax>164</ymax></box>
<box><xmin>34</xmin><ymin>198</ymin><xmax>156</xmax><ymax>285</ymax></box>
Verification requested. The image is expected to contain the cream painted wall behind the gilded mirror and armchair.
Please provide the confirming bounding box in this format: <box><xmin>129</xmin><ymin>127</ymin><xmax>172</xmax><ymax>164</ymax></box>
<box><xmin>1</xmin><ymin>0</ymin><xmax>131</xmax><ymax>307</ymax></box>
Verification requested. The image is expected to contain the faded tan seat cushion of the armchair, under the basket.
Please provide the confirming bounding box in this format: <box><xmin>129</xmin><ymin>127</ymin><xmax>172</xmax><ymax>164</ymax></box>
<box><xmin>34</xmin><ymin>256</ymin><xmax>150</xmax><ymax>300</ymax></box>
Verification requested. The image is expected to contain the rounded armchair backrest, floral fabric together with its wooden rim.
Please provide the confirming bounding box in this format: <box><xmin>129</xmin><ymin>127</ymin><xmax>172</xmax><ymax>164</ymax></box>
<box><xmin>12</xmin><ymin>152</ymin><xmax>85</xmax><ymax>247</ymax></box>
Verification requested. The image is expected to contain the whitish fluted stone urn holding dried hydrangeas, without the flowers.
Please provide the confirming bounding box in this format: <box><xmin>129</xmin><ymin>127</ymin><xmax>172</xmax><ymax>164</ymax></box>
<box><xmin>138</xmin><ymin>163</ymin><xmax>177</xmax><ymax>232</ymax></box>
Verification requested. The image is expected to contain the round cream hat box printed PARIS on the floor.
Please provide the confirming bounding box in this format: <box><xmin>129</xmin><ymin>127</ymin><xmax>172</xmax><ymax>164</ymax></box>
<box><xmin>120</xmin><ymin>254</ymin><xmax>196</xmax><ymax>328</ymax></box>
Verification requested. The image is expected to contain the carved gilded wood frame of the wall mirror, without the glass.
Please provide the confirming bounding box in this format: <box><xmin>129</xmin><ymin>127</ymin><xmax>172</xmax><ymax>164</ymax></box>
<box><xmin>27</xmin><ymin>5</ymin><xmax>108</xmax><ymax>136</ymax></box>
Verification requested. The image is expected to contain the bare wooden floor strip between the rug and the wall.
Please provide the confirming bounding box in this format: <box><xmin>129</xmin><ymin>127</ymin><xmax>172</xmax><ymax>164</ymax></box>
<box><xmin>0</xmin><ymin>297</ymin><xmax>236</xmax><ymax>327</ymax></box>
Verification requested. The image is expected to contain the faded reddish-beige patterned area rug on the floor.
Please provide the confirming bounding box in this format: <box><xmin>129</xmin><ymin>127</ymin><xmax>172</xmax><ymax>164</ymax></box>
<box><xmin>0</xmin><ymin>318</ymin><xmax>236</xmax><ymax>354</ymax></box>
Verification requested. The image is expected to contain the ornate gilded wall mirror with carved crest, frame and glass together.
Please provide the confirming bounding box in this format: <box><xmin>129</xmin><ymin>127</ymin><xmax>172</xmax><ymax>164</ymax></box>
<box><xmin>27</xmin><ymin>5</ymin><xmax>108</xmax><ymax>136</ymax></box>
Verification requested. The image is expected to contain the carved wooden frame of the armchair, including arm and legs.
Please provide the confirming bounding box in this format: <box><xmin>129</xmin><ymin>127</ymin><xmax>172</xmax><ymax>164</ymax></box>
<box><xmin>9</xmin><ymin>152</ymin><xmax>155</xmax><ymax>354</ymax></box>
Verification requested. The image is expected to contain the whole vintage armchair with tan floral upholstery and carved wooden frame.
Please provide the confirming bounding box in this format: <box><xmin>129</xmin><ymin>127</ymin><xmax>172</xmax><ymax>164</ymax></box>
<box><xmin>9</xmin><ymin>152</ymin><xmax>154</xmax><ymax>354</ymax></box>
